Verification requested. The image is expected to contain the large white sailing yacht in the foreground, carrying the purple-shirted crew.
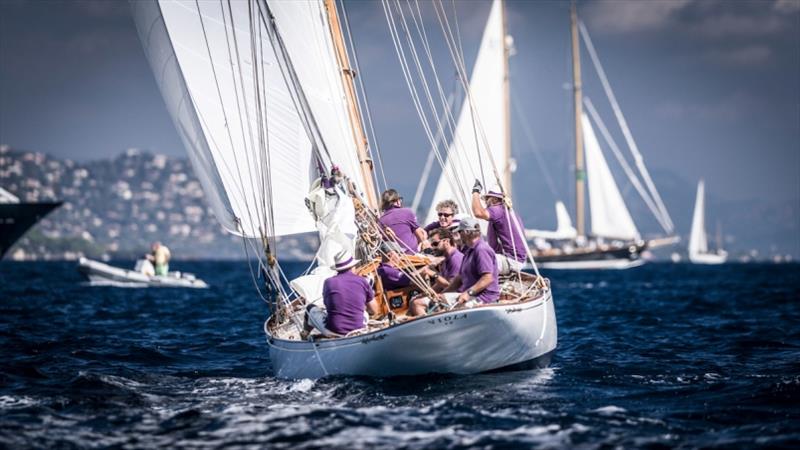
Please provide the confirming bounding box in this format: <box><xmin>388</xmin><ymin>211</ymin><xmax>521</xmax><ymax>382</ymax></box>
<box><xmin>133</xmin><ymin>0</ymin><xmax>557</xmax><ymax>378</ymax></box>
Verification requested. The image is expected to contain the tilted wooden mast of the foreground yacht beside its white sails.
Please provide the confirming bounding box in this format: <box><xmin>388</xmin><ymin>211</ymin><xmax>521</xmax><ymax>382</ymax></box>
<box><xmin>325</xmin><ymin>0</ymin><xmax>378</xmax><ymax>209</ymax></box>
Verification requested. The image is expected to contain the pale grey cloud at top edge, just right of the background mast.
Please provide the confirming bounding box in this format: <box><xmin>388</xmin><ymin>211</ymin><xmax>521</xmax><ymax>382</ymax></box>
<box><xmin>583</xmin><ymin>0</ymin><xmax>692</xmax><ymax>33</ymax></box>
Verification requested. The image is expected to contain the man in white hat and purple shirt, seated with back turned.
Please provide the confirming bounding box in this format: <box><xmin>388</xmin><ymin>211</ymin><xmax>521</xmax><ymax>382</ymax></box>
<box><xmin>305</xmin><ymin>250</ymin><xmax>379</xmax><ymax>337</ymax></box>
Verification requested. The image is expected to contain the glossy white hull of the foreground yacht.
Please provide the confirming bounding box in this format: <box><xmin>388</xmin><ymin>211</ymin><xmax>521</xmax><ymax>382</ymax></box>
<box><xmin>264</xmin><ymin>292</ymin><xmax>558</xmax><ymax>379</ymax></box>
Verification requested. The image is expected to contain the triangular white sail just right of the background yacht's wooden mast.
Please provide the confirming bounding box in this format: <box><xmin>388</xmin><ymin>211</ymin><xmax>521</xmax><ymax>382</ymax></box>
<box><xmin>581</xmin><ymin>114</ymin><xmax>639</xmax><ymax>239</ymax></box>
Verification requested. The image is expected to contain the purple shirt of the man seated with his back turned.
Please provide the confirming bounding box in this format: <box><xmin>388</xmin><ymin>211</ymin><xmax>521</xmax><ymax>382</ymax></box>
<box><xmin>322</xmin><ymin>270</ymin><xmax>373</xmax><ymax>334</ymax></box>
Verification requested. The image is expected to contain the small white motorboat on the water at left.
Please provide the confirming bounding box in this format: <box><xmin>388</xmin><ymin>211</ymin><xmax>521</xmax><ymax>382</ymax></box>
<box><xmin>78</xmin><ymin>258</ymin><xmax>208</xmax><ymax>289</ymax></box>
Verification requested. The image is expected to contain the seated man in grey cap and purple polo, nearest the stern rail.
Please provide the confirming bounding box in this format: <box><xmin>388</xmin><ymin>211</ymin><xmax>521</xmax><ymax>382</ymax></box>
<box><xmin>409</xmin><ymin>217</ymin><xmax>500</xmax><ymax>316</ymax></box>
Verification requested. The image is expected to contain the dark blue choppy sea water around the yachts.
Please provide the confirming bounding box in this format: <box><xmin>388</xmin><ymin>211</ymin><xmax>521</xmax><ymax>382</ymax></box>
<box><xmin>0</xmin><ymin>262</ymin><xmax>800</xmax><ymax>448</ymax></box>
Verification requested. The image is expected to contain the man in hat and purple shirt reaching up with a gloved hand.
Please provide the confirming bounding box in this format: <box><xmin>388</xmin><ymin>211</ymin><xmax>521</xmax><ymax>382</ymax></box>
<box><xmin>472</xmin><ymin>180</ymin><xmax>527</xmax><ymax>275</ymax></box>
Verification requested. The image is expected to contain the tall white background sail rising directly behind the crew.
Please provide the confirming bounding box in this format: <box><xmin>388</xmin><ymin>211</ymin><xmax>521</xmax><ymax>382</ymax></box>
<box><xmin>425</xmin><ymin>0</ymin><xmax>508</xmax><ymax>223</ymax></box>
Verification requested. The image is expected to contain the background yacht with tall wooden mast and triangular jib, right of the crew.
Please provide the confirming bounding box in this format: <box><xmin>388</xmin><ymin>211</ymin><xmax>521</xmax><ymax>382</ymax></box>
<box><xmin>526</xmin><ymin>3</ymin><xmax>677</xmax><ymax>269</ymax></box>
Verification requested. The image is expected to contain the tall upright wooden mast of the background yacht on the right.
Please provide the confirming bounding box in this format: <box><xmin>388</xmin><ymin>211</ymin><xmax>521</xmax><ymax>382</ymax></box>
<box><xmin>570</xmin><ymin>0</ymin><xmax>586</xmax><ymax>236</ymax></box>
